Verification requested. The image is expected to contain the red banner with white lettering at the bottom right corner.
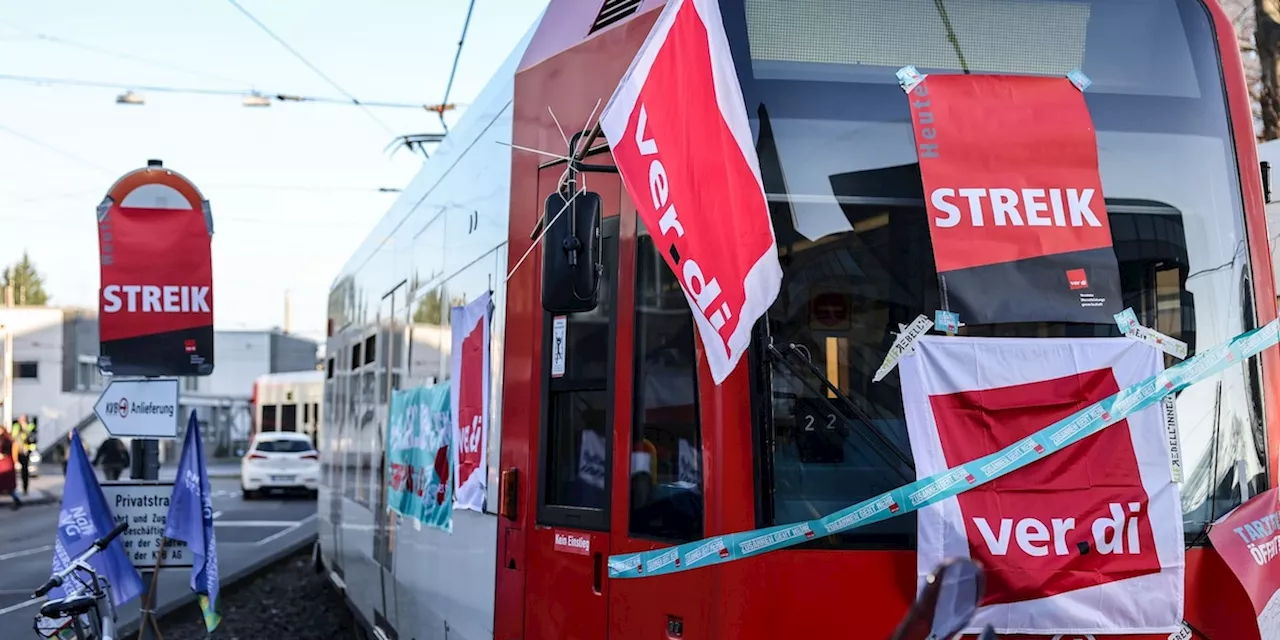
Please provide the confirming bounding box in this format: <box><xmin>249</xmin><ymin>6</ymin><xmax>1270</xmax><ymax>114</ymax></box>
<box><xmin>1208</xmin><ymin>489</ymin><xmax>1280</xmax><ymax>640</ymax></box>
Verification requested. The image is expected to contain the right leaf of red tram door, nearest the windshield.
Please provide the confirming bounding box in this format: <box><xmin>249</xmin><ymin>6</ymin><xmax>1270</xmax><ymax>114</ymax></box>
<box><xmin>609</xmin><ymin>193</ymin><xmax>716</xmax><ymax>640</ymax></box>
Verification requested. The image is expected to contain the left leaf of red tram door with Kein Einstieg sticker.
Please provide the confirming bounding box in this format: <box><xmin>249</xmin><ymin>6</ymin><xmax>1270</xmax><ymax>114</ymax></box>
<box><xmin>524</xmin><ymin>166</ymin><xmax>621</xmax><ymax>640</ymax></box>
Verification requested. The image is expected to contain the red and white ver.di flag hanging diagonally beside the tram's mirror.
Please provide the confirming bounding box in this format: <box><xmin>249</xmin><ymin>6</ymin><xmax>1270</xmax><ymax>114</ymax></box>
<box><xmin>600</xmin><ymin>0</ymin><xmax>782</xmax><ymax>384</ymax></box>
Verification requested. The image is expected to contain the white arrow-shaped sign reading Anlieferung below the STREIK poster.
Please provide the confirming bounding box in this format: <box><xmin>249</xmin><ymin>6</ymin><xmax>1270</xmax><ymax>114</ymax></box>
<box><xmin>93</xmin><ymin>378</ymin><xmax>178</xmax><ymax>438</ymax></box>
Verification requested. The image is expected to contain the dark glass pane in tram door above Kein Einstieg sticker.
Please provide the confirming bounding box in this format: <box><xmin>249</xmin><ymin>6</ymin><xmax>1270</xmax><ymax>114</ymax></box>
<box><xmin>538</xmin><ymin>218</ymin><xmax>618</xmax><ymax>530</ymax></box>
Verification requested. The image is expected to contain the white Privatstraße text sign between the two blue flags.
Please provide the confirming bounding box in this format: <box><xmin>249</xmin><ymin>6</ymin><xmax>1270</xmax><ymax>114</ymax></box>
<box><xmin>102</xmin><ymin>483</ymin><xmax>195</xmax><ymax>571</ymax></box>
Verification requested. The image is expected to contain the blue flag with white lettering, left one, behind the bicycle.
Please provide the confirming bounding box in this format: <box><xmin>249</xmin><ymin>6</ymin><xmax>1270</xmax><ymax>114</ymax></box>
<box><xmin>49</xmin><ymin>431</ymin><xmax>146</xmax><ymax>607</ymax></box>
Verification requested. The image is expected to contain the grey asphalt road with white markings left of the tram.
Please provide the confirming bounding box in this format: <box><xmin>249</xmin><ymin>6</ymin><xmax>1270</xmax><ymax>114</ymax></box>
<box><xmin>0</xmin><ymin>471</ymin><xmax>316</xmax><ymax>640</ymax></box>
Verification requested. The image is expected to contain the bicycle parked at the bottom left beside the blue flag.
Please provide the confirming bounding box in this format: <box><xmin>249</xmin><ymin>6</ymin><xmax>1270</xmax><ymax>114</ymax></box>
<box><xmin>31</xmin><ymin>522</ymin><xmax>129</xmax><ymax>640</ymax></box>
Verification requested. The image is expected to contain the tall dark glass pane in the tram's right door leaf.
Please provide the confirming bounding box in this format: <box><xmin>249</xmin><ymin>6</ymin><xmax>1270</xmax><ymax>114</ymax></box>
<box><xmin>630</xmin><ymin>229</ymin><xmax>703</xmax><ymax>540</ymax></box>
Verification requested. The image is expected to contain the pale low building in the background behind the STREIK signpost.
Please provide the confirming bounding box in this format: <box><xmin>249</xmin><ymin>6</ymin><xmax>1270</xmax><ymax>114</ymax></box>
<box><xmin>0</xmin><ymin>307</ymin><xmax>319</xmax><ymax>456</ymax></box>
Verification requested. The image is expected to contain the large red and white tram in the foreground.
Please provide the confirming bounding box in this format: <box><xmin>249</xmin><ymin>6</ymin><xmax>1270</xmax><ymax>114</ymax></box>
<box><xmin>317</xmin><ymin>0</ymin><xmax>1280</xmax><ymax>640</ymax></box>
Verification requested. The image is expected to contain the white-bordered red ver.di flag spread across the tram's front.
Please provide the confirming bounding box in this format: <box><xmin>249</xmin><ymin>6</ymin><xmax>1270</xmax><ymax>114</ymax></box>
<box><xmin>900</xmin><ymin>337</ymin><xmax>1184</xmax><ymax>634</ymax></box>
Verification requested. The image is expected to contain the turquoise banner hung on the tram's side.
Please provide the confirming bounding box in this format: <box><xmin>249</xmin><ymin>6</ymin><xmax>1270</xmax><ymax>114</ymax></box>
<box><xmin>387</xmin><ymin>383</ymin><xmax>453</xmax><ymax>531</ymax></box>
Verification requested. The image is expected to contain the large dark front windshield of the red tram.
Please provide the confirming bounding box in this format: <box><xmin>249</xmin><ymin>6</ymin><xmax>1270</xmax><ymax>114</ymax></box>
<box><xmin>723</xmin><ymin>0</ymin><xmax>1266</xmax><ymax>548</ymax></box>
